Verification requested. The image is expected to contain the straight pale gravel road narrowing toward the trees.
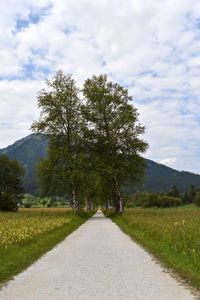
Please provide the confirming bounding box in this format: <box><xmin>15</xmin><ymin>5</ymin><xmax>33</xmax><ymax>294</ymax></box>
<box><xmin>0</xmin><ymin>212</ymin><xmax>196</xmax><ymax>300</ymax></box>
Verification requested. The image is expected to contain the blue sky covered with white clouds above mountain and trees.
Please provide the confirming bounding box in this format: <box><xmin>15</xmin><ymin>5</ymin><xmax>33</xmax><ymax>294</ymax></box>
<box><xmin>0</xmin><ymin>0</ymin><xmax>200</xmax><ymax>174</ymax></box>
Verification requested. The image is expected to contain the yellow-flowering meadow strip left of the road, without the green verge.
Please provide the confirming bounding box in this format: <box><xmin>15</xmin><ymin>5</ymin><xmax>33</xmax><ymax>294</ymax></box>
<box><xmin>0</xmin><ymin>208</ymin><xmax>73</xmax><ymax>249</ymax></box>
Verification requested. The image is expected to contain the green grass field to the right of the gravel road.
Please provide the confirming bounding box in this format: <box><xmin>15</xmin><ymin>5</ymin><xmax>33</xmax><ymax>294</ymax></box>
<box><xmin>106</xmin><ymin>207</ymin><xmax>200</xmax><ymax>289</ymax></box>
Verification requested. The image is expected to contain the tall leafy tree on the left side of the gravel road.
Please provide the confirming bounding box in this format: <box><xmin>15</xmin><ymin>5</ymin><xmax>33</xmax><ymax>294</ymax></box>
<box><xmin>31</xmin><ymin>71</ymin><xmax>81</xmax><ymax>211</ymax></box>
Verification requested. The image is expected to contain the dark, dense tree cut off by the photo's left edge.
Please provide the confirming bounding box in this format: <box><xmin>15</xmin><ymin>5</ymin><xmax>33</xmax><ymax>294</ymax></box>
<box><xmin>0</xmin><ymin>155</ymin><xmax>24</xmax><ymax>210</ymax></box>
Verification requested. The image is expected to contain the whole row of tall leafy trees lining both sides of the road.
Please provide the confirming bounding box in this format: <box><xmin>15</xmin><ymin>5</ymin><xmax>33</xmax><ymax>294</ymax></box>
<box><xmin>32</xmin><ymin>71</ymin><xmax>148</xmax><ymax>214</ymax></box>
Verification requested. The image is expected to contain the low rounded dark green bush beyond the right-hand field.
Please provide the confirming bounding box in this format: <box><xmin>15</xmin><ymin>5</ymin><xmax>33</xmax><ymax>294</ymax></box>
<box><xmin>143</xmin><ymin>193</ymin><xmax>183</xmax><ymax>208</ymax></box>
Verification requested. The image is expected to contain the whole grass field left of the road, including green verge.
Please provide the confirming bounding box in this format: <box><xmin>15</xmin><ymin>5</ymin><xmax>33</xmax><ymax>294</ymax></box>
<box><xmin>0</xmin><ymin>208</ymin><xmax>92</xmax><ymax>283</ymax></box>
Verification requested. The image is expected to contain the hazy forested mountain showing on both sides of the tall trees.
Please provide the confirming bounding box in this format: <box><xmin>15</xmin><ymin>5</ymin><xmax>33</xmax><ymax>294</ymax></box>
<box><xmin>0</xmin><ymin>134</ymin><xmax>200</xmax><ymax>194</ymax></box>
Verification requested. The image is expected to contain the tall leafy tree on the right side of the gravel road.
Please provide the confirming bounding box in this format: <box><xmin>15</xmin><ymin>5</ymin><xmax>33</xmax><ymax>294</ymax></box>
<box><xmin>82</xmin><ymin>75</ymin><xmax>148</xmax><ymax>214</ymax></box>
